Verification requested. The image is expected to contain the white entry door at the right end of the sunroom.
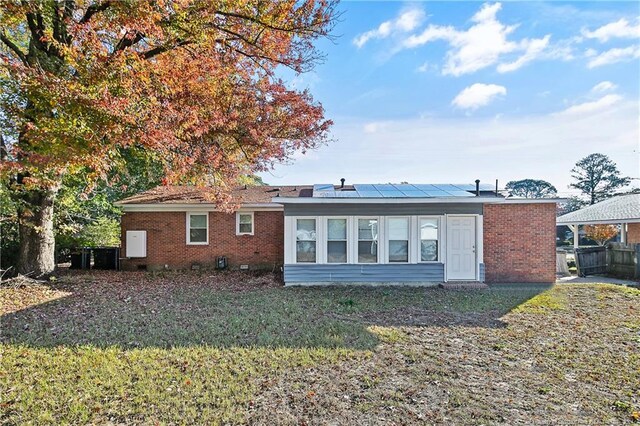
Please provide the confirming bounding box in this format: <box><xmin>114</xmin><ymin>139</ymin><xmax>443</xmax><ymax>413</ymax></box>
<box><xmin>446</xmin><ymin>216</ymin><xmax>477</xmax><ymax>281</ymax></box>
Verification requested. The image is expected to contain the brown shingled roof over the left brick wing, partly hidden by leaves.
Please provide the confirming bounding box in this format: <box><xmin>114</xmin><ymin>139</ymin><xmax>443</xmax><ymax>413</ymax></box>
<box><xmin>117</xmin><ymin>185</ymin><xmax>312</xmax><ymax>206</ymax></box>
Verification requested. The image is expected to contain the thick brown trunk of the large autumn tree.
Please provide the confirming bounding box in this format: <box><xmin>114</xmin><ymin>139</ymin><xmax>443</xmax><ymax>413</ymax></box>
<box><xmin>16</xmin><ymin>187</ymin><xmax>58</xmax><ymax>278</ymax></box>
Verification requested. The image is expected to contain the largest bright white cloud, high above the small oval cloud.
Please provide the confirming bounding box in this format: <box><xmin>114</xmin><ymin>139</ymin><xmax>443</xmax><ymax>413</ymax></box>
<box><xmin>402</xmin><ymin>3</ymin><xmax>550</xmax><ymax>76</ymax></box>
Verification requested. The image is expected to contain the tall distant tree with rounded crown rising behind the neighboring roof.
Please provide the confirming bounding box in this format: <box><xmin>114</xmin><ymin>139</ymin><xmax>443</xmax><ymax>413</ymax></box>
<box><xmin>569</xmin><ymin>153</ymin><xmax>631</xmax><ymax>204</ymax></box>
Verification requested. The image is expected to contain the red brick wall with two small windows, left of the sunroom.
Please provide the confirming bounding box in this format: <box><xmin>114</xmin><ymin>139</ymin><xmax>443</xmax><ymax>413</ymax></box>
<box><xmin>121</xmin><ymin>211</ymin><xmax>284</xmax><ymax>270</ymax></box>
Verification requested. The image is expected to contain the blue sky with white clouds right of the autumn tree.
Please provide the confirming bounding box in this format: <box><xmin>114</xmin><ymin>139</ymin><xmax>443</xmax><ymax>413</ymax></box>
<box><xmin>262</xmin><ymin>1</ymin><xmax>640</xmax><ymax>195</ymax></box>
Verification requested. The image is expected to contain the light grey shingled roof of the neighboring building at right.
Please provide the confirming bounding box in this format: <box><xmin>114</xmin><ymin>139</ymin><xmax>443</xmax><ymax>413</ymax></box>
<box><xmin>556</xmin><ymin>194</ymin><xmax>640</xmax><ymax>225</ymax></box>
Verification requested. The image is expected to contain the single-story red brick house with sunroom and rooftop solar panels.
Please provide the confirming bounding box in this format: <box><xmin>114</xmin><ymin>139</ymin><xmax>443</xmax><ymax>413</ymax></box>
<box><xmin>118</xmin><ymin>182</ymin><xmax>557</xmax><ymax>285</ymax></box>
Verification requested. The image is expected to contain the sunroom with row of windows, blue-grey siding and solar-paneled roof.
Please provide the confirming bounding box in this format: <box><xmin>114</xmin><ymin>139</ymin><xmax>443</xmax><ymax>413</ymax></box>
<box><xmin>274</xmin><ymin>184</ymin><xmax>501</xmax><ymax>285</ymax></box>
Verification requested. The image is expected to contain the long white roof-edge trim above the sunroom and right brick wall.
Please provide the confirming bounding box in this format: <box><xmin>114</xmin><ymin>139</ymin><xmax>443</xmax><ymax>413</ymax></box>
<box><xmin>271</xmin><ymin>196</ymin><xmax>566</xmax><ymax>204</ymax></box>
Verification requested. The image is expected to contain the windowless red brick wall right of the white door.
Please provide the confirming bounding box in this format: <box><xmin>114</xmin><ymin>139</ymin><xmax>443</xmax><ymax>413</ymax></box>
<box><xmin>483</xmin><ymin>203</ymin><xmax>556</xmax><ymax>282</ymax></box>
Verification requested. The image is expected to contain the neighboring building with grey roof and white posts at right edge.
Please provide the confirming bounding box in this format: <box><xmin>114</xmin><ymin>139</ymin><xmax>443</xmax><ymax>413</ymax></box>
<box><xmin>556</xmin><ymin>194</ymin><xmax>640</xmax><ymax>247</ymax></box>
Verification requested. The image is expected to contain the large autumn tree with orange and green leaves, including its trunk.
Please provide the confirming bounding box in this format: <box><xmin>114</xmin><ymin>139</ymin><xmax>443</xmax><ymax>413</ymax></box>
<box><xmin>0</xmin><ymin>0</ymin><xmax>336</xmax><ymax>275</ymax></box>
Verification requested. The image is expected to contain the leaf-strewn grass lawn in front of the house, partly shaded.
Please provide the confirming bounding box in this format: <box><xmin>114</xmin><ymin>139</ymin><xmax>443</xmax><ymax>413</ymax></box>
<box><xmin>0</xmin><ymin>273</ymin><xmax>640</xmax><ymax>424</ymax></box>
